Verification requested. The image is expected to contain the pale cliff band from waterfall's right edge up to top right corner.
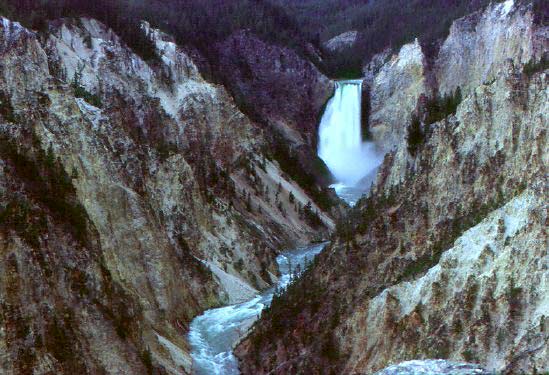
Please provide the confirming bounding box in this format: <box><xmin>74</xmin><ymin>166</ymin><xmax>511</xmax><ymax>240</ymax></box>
<box><xmin>363</xmin><ymin>0</ymin><xmax>547</xmax><ymax>156</ymax></box>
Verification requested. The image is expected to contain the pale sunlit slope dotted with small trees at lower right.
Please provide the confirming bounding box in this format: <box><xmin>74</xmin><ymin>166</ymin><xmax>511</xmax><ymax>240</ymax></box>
<box><xmin>344</xmin><ymin>186</ymin><xmax>549</xmax><ymax>373</ymax></box>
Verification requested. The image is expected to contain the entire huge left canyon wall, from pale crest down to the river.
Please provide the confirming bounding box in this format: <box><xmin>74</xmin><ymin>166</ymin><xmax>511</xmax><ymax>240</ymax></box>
<box><xmin>0</xmin><ymin>18</ymin><xmax>333</xmax><ymax>373</ymax></box>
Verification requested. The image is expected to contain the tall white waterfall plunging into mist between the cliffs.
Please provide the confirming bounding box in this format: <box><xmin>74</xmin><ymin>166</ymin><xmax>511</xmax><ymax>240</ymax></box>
<box><xmin>318</xmin><ymin>80</ymin><xmax>382</xmax><ymax>205</ymax></box>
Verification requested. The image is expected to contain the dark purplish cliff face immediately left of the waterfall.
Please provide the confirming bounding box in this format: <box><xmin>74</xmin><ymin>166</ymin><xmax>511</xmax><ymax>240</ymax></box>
<box><xmin>217</xmin><ymin>31</ymin><xmax>334</xmax><ymax>189</ymax></box>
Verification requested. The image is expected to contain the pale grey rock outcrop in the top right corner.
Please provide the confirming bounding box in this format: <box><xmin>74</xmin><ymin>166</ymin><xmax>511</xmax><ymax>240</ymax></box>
<box><xmin>435</xmin><ymin>0</ymin><xmax>549</xmax><ymax>95</ymax></box>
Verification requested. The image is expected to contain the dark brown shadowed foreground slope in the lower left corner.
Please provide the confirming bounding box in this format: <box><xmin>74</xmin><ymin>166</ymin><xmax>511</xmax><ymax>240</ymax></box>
<box><xmin>0</xmin><ymin>136</ymin><xmax>153</xmax><ymax>374</ymax></box>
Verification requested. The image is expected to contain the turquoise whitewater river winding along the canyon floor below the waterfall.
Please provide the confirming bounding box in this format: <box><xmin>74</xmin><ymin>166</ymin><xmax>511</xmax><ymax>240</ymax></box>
<box><xmin>189</xmin><ymin>243</ymin><xmax>326</xmax><ymax>375</ymax></box>
